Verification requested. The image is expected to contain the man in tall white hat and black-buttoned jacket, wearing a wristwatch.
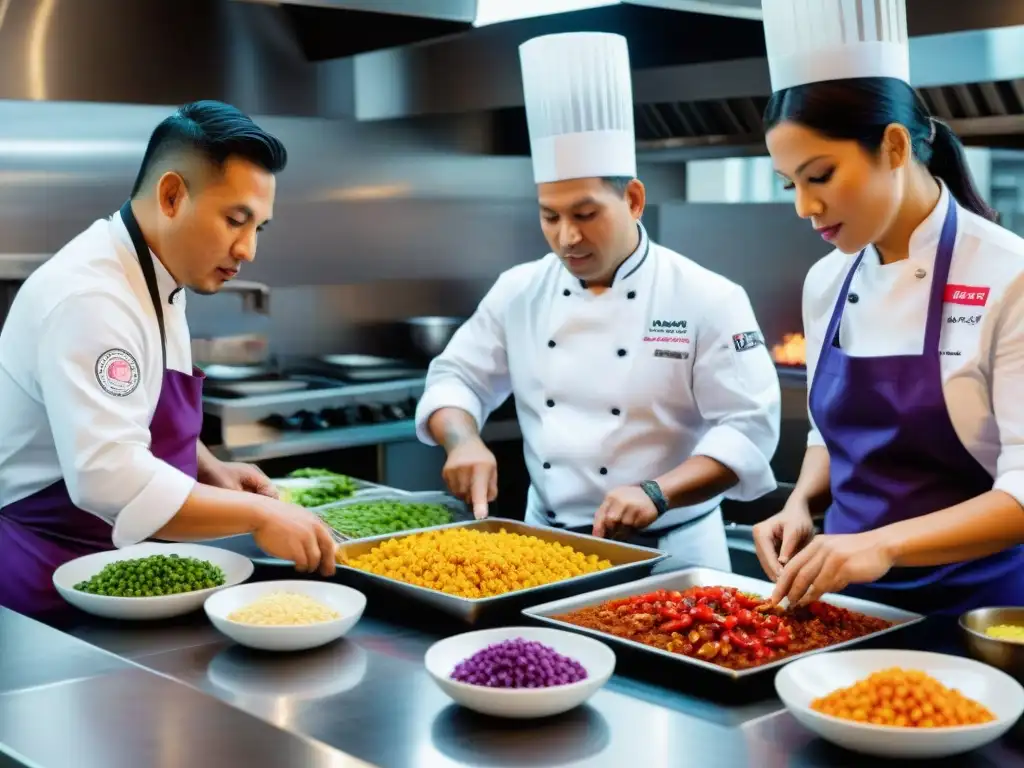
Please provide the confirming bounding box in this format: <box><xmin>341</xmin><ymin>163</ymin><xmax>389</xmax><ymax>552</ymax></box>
<box><xmin>416</xmin><ymin>33</ymin><xmax>780</xmax><ymax>569</ymax></box>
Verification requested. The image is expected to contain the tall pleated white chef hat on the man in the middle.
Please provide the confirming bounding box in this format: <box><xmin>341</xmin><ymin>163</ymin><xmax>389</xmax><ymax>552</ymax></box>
<box><xmin>519</xmin><ymin>32</ymin><xmax>637</xmax><ymax>184</ymax></box>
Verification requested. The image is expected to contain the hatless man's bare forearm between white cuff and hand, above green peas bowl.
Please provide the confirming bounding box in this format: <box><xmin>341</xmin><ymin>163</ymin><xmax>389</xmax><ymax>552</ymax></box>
<box><xmin>154</xmin><ymin>483</ymin><xmax>268</xmax><ymax>542</ymax></box>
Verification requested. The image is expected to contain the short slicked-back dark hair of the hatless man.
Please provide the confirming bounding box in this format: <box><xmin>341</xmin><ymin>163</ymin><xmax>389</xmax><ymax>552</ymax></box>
<box><xmin>131</xmin><ymin>100</ymin><xmax>288</xmax><ymax>198</ymax></box>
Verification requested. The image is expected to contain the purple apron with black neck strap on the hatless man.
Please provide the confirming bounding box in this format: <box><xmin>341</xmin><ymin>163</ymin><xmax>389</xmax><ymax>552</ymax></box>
<box><xmin>0</xmin><ymin>201</ymin><xmax>203</xmax><ymax>620</ymax></box>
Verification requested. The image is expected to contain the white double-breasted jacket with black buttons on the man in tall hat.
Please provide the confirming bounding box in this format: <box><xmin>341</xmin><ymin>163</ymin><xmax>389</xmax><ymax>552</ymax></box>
<box><xmin>416</xmin><ymin>226</ymin><xmax>780</xmax><ymax>530</ymax></box>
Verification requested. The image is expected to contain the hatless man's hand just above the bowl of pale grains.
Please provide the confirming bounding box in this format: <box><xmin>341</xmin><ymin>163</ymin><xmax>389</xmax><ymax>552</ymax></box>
<box><xmin>253</xmin><ymin>499</ymin><xmax>335</xmax><ymax>577</ymax></box>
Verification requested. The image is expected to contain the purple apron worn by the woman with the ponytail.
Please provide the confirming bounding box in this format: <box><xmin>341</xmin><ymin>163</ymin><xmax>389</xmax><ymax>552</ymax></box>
<box><xmin>810</xmin><ymin>200</ymin><xmax>1024</xmax><ymax>614</ymax></box>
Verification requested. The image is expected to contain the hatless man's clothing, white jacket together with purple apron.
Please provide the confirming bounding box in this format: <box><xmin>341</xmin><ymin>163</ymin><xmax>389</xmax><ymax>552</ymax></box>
<box><xmin>0</xmin><ymin>203</ymin><xmax>203</xmax><ymax>618</ymax></box>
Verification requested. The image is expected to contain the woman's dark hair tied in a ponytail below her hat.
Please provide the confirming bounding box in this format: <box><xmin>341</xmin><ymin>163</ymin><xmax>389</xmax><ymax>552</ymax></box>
<box><xmin>764</xmin><ymin>78</ymin><xmax>998</xmax><ymax>221</ymax></box>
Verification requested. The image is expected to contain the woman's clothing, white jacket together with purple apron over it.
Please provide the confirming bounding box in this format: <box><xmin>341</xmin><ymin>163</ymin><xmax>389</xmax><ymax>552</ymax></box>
<box><xmin>804</xmin><ymin>184</ymin><xmax>1024</xmax><ymax>614</ymax></box>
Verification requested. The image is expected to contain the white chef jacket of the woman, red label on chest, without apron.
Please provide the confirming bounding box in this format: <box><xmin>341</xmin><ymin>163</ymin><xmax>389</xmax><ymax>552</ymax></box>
<box><xmin>803</xmin><ymin>184</ymin><xmax>1024</xmax><ymax>504</ymax></box>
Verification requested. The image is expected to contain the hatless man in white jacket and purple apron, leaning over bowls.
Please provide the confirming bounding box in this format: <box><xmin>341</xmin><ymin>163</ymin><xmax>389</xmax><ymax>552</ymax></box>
<box><xmin>0</xmin><ymin>101</ymin><xmax>335</xmax><ymax>621</ymax></box>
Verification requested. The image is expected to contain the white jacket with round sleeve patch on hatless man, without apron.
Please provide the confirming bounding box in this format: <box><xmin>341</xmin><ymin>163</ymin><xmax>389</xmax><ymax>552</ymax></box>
<box><xmin>0</xmin><ymin>208</ymin><xmax>196</xmax><ymax>547</ymax></box>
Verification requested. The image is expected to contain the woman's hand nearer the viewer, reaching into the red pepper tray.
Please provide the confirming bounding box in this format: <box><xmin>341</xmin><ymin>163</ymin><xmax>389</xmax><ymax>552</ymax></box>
<box><xmin>771</xmin><ymin>530</ymin><xmax>893</xmax><ymax>607</ymax></box>
